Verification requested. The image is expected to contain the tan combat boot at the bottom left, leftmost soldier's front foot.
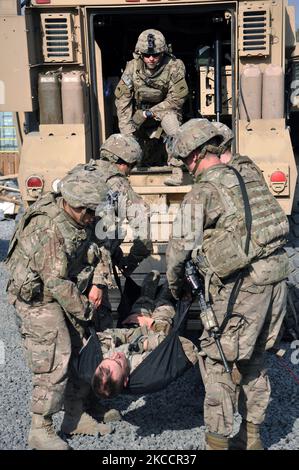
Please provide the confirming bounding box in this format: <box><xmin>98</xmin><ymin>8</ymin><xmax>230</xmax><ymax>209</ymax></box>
<box><xmin>28</xmin><ymin>414</ymin><xmax>71</xmax><ymax>450</ymax></box>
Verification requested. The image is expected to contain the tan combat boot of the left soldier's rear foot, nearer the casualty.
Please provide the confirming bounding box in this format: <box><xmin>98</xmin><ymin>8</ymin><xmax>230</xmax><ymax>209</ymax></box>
<box><xmin>61</xmin><ymin>400</ymin><xmax>113</xmax><ymax>436</ymax></box>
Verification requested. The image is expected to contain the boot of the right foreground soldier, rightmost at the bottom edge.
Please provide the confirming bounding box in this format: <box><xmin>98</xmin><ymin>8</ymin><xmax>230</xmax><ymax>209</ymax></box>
<box><xmin>229</xmin><ymin>420</ymin><xmax>264</xmax><ymax>450</ymax></box>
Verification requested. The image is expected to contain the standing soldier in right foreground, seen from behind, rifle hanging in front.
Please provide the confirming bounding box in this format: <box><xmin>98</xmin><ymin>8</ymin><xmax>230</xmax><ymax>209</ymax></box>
<box><xmin>166</xmin><ymin>119</ymin><xmax>289</xmax><ymax>450</ymax></box>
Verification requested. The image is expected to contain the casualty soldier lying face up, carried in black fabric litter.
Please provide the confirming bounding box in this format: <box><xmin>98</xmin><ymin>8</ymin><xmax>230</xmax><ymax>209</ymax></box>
<box><xmin>93</xmin><ymin>271</ymin><xmax>198</xmax><ymax>398</ymax></box>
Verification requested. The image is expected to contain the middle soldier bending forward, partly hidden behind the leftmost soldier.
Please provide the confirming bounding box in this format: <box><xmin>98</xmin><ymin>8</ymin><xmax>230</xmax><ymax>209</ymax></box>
<box><xmin>62</xmin><ymin>134</ymin><xmax>152</xmax><ymax>330</ymax></box>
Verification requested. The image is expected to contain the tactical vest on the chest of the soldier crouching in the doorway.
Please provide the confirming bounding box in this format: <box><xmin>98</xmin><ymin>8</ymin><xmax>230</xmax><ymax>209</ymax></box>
<box><xmin>132</xmin><ymin>57</ymin><xmax>174</xmax><ymax>109</ymax></box>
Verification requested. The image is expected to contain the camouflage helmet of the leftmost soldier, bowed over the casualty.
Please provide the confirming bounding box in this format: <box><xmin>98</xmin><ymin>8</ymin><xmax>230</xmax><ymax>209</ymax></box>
<box><xmin>59</xmin><ymin>172</ymin><xmax>109</xmax><ymax>211</ymax></box>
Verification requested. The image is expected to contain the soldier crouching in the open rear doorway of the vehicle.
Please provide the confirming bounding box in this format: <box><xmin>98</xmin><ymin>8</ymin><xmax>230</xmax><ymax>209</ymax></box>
<box><xmin>115</xmin><ymin>29</ymin><xmax>188</xmax><ymax>186</ymax></box>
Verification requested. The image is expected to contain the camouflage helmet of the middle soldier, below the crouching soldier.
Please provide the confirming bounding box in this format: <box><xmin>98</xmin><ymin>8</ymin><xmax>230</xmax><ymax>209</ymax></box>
<box><xmin>100</xmin><ymin>134</ymin><xmax>142</xmax><ymax>165</ymax></box>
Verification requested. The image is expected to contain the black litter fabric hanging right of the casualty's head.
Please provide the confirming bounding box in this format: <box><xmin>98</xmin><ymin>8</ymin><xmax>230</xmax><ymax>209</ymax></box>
<box><xmin>124</xmin><ymin>301</ymin><xmax>193</xmax><ymax>395</ymax></box>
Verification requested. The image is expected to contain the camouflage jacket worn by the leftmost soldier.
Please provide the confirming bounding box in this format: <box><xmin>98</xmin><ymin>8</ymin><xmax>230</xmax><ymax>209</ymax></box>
<box><xmin>6</xmin><ymin>193</ymin><xmax>98</xmax><ymax>321</ymax></box>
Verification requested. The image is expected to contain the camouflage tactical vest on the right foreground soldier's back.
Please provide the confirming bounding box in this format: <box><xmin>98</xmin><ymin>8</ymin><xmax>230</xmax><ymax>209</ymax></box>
<box><xmin>199</xmin><ymin>165</ymin><xmax>289</xmax><ymax>279</ymax></box>
